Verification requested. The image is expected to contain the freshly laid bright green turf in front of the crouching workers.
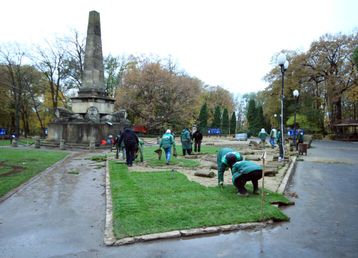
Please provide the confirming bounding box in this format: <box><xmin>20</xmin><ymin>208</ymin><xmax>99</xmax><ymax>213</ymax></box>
<box><xmin>109</xmin><ymin>162</ymin><xmax>289</xmax><ymax>239</ymax></box>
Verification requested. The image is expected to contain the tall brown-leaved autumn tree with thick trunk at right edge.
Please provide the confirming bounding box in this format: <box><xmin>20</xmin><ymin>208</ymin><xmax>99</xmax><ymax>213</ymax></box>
<box><xmin>304</xmin><ymin>34</ymin><xmax>358</xmax><ymax>131</ymax></box>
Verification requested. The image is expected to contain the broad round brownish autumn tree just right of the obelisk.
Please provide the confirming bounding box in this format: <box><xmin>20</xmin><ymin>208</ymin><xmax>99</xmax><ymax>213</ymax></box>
<box><xmin>116</xmin><ymin>61</ymin><xmax>201</xmax><ymax>132</ymax></box>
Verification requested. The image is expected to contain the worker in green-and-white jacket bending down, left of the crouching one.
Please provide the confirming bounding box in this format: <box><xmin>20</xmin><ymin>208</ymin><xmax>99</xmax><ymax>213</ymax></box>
<box><xmin>217</xmin><ymin>148</ymin><xmax>242</xmax><ymax>186</ymax></box>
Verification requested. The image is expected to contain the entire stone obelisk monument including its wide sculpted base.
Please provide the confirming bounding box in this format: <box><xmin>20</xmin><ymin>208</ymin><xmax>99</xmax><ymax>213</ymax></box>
<box><xmin>47</xmin><ymin>11</ymin><xmax>131</xmax><ymax>147</ymax></box>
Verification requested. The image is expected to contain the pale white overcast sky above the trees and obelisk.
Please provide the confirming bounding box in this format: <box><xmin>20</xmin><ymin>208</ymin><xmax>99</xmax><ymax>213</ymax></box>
<box><xmin>0</xmin><ymin>0</ymin><xmax>358</xmax><ymax>93</ymax></box>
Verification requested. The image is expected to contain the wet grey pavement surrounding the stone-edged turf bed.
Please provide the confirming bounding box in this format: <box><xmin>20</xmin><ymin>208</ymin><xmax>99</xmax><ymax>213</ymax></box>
<box><xmin>0</xmin><ymin>141</ymin><xmax>358</xmax><ymax>258</ymax></box>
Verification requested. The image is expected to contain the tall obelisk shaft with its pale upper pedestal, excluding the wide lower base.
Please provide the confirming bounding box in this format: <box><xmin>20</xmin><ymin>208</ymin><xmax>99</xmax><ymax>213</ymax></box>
<box><xmin>72</xmin><ymin>11</ymin><xmax>114</xmax><ymax>115</ymax></box>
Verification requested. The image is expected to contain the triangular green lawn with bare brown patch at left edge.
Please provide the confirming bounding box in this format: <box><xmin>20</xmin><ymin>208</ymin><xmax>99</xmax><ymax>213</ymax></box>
<box><xmin>0</xmin><ymin>148</ymin><xmax>68</xmax><ymax>197</ymax></box>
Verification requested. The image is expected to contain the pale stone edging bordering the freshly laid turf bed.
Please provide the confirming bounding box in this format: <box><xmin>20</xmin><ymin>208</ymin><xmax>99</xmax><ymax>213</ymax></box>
<box><xmin>104</xmin><ymin>156</ymin><xmax>297</xmax><ymax>246</ymax></box>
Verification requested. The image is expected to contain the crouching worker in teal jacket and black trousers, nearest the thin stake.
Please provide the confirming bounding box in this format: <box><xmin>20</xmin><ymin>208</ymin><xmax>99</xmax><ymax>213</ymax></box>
<box><xmin>231</xmin><ymin>160</ymin><xmax>262</xmax><ymax>197</ymax></box>
